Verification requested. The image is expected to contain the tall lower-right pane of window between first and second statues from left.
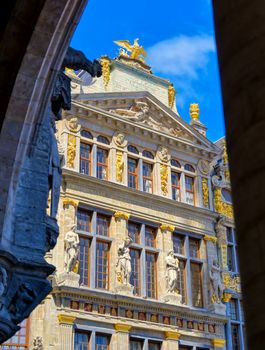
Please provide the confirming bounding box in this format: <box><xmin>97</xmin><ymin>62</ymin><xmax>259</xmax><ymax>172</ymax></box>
<box><xmin>96</xmin><ymin>241</ymin><xmax>109</xmax><ymax>289</ymax></box>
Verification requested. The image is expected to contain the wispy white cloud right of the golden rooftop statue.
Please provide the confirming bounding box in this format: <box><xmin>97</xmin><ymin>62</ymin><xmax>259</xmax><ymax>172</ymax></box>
<box><xmin>147</xmin><ymin>35</ymin><xmax>215</xmax><ymax>80</ymax></box>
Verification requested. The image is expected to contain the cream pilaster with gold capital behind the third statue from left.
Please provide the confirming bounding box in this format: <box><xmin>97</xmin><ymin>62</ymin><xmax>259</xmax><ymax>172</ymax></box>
<box><xmin>157</xmin><ymin>224</ymin><xmax>175</xmax><ymax>297</ymax></box>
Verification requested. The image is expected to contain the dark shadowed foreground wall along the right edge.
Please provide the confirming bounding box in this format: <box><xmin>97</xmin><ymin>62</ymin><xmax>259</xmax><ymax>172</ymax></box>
<box><xmin>213</xmin><ymin>0</ymin><xmax>265</xmax><ymax>350</ymax></box>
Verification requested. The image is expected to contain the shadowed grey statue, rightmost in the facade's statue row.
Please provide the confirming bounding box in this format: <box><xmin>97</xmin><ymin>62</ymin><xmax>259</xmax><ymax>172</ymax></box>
<box><xmin>209</xmin><ymin>260</ymin><xmax>223</xmax><ymax>303</ymax></box>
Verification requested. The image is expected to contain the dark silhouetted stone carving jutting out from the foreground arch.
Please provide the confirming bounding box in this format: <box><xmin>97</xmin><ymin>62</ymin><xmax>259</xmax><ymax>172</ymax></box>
<box><xmin>51</xmin><ymin>47</ymin><xmax>102</xmax><ymax>120</ymax></box>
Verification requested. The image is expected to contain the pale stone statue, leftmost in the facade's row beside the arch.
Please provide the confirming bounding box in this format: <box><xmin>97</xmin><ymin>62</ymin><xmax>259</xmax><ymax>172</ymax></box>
<box><xmin>64</xmin><ymin>225</ymin><xmax>79</xmax><ymax>273</ymax></box>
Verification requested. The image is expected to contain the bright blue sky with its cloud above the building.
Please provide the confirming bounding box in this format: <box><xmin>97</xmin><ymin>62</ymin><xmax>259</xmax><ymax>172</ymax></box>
<box><xmin>71</xmin><ymin>0</ymin><xmax>224</xmax><ymax>141</ymax></box>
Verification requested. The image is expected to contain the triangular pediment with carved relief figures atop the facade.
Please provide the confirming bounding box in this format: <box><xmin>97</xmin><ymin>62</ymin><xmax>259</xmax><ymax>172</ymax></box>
<box><xmin>72</xmin><ymin>92</ymin><xmax>218</xmax><ymax>152</ymax></box>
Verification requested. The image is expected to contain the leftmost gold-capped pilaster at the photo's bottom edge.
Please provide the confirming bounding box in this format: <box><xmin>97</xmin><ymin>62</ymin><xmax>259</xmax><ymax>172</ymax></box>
<box><xmin>57</xmin><ymin>314</ymin><xmax>76</xmax><ymax>350</ymax></box>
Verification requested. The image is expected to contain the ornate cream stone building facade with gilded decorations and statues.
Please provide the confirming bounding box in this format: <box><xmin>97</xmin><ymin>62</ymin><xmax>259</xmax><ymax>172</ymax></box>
<box><xmin>2</xmin><ymin>43</ymin><xmax>246</xmax><ymax>350</ymax></box>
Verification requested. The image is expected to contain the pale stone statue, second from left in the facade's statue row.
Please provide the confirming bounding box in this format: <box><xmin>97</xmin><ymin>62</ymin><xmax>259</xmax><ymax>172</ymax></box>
<box><xmin>116</xmin><ymin>237</ymin><xmax>132</xmax><ymax>285</ymax></box>
